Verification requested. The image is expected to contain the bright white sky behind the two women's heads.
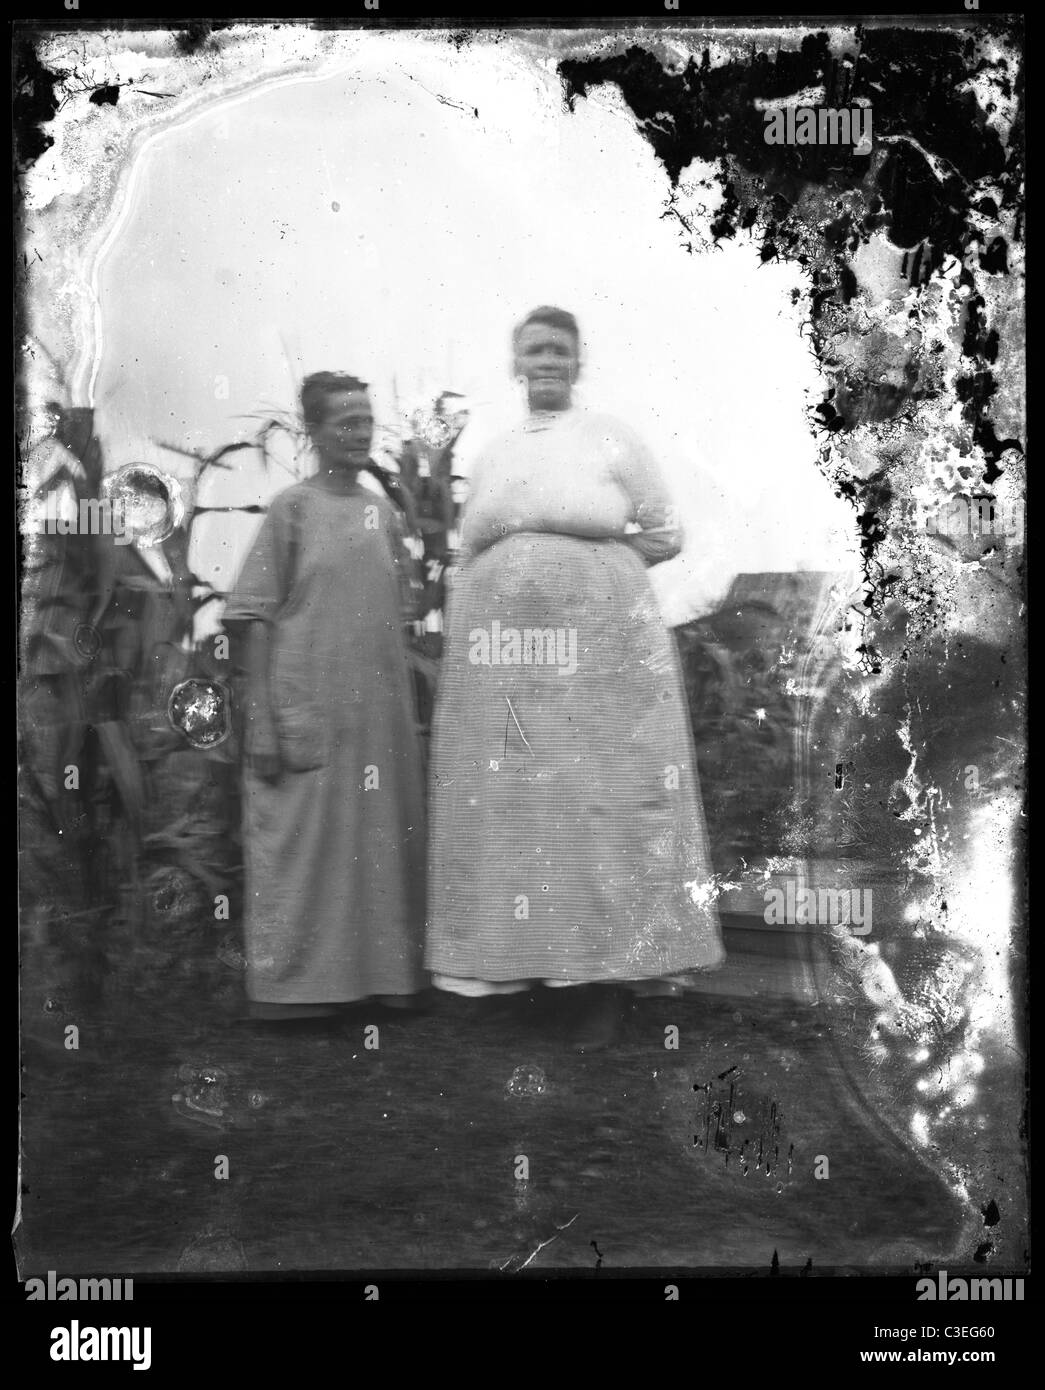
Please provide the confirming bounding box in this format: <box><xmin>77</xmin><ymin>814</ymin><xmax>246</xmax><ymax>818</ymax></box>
<box><xmin>81</xmin><ymin>32</ymin><xmax>857</xmax><ymax>619</ymax></box>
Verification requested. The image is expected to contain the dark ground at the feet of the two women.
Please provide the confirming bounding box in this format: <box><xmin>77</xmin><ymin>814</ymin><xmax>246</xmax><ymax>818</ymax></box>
<box><xmin>17</xmin><ymin>945</ymin><xmax>969</xmax><ymax>1277</ymax></box>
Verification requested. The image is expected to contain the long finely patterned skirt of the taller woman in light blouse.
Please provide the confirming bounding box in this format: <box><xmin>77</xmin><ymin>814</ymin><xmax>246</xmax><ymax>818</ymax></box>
<box><xmin>425</xmin><ymin>532</ymin><xmax>724</xmax><ymax>992</ymax></box>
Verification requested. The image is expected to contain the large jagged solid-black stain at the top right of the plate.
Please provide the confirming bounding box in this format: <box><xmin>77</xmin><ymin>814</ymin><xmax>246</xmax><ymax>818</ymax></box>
<box><xmin>559</xmin><ymin>28</ymin><xmax>1017</xmax><ymax>214</ymax></box>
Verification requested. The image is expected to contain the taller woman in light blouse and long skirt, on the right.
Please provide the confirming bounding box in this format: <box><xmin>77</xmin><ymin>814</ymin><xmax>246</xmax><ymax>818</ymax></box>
<box><xmin>425</xmin><ymin>307</ymin><xmax>724</xmax><ymax>1049</ymax></box>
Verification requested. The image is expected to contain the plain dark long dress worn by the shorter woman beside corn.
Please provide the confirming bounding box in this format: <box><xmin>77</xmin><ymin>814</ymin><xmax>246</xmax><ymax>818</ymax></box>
<box><xmin>225</xmin><ymin>481</ymin><xmax>425</xmax><ymax>1005</ymax></box>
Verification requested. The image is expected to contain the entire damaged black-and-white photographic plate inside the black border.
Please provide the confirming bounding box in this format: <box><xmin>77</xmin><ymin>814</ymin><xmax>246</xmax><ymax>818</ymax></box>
<box><xmin>14</xmin><ymin>11</ymin><xmax>1028</xmax><ymax>1289</ymax></box>
